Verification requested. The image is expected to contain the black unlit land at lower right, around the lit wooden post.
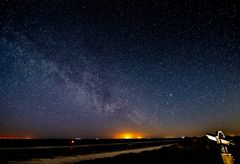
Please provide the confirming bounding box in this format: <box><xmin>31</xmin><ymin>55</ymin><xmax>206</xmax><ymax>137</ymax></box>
<box><xmin>80</xmin><ymin>137</ymin><xmax>240</xmax><ymax>164</ymax></box>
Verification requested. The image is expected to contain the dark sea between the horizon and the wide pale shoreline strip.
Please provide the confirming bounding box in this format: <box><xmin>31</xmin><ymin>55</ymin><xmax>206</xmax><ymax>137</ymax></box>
<box><xmin>0</xmin><ymin>139</ymin><xmax>176</xmax><ymax>163</ymax></box>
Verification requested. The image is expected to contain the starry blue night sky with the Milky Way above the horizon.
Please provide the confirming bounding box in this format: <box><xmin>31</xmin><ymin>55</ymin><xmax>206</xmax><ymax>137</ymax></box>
<box><xmin>0</xmin><ymin>0</ymin><xmax>240</xmax><ymax>138</ymax></box>
